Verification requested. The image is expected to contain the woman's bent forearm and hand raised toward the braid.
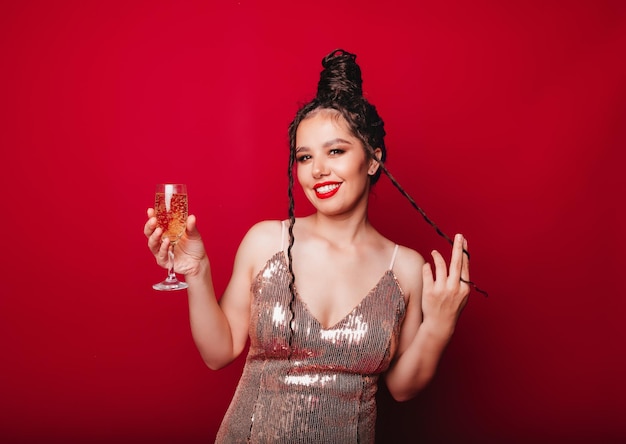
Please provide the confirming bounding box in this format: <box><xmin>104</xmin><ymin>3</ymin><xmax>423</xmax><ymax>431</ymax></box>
<box><xmin>385</xmin><ymin>235</ymin><xmax>469</xmax><ymax>401</ymax></box>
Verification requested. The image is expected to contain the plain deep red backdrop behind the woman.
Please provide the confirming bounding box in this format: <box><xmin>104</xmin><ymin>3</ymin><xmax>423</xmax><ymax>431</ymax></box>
<box><xmin>0</xmin><ymin>0</ymin><xmax>626</xmax><ymax>443</ymax></box>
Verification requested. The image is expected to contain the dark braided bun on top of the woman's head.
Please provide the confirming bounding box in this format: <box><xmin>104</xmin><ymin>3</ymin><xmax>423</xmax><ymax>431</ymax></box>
<box><xmin>317</xmin><ymin>49</ymin><xmax>363</xmax><ymax>102</ymax></box>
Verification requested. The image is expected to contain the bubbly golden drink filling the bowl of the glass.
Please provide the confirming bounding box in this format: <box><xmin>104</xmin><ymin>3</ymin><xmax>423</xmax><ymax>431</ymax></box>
<box><xmin>154</xmin><ymin>185</ymin><xmax>187</xmax><ymax>243</ymax></box>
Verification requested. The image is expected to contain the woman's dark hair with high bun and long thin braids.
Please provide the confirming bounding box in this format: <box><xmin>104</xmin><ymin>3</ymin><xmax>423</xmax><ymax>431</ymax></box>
<box><xmin>287</xmin><ymin>49</ymin><xmax>486</xmax><ymax>336</ymax></box>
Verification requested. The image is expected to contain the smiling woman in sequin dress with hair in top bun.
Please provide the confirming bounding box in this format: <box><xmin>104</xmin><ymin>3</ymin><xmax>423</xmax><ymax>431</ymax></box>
<box><xmin>144</xmin><ymin>50</ymin><xmax>470</xmax><ymax>443</ymax></box>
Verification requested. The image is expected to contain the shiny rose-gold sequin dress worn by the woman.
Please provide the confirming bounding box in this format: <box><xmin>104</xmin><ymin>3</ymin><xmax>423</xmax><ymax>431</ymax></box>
<box><xmin>216</xmin><ymin>251</ymin><xmax>405</xmax><ymax>444</ymax></box>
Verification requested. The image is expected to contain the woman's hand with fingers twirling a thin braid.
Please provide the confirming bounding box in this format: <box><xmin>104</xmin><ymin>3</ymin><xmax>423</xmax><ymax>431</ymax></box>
<box><xmin>422</xmin><ymin>234</ymin><xmax>470</xmax><ymax>334</ymax></box>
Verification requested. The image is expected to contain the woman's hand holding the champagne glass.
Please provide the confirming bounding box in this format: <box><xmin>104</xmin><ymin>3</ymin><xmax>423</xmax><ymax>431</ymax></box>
<box><xmin>143</xmin><ymin>208</ymin><xmax>208</xmax><ymax>275</ymax></box>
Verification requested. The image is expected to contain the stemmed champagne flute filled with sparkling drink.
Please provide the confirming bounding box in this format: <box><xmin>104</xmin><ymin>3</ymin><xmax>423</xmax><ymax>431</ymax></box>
<box><xmin>152</xmin><ymin>183</ymin><xmax>187</xmax><ymax>291</ymax></box>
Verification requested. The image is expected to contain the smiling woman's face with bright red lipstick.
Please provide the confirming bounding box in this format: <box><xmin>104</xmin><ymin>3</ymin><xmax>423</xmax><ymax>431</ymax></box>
<box><xmin>296</xmin><ymin>110</ymin><xmax>379</xmax><ymax>215</ymax></box>
